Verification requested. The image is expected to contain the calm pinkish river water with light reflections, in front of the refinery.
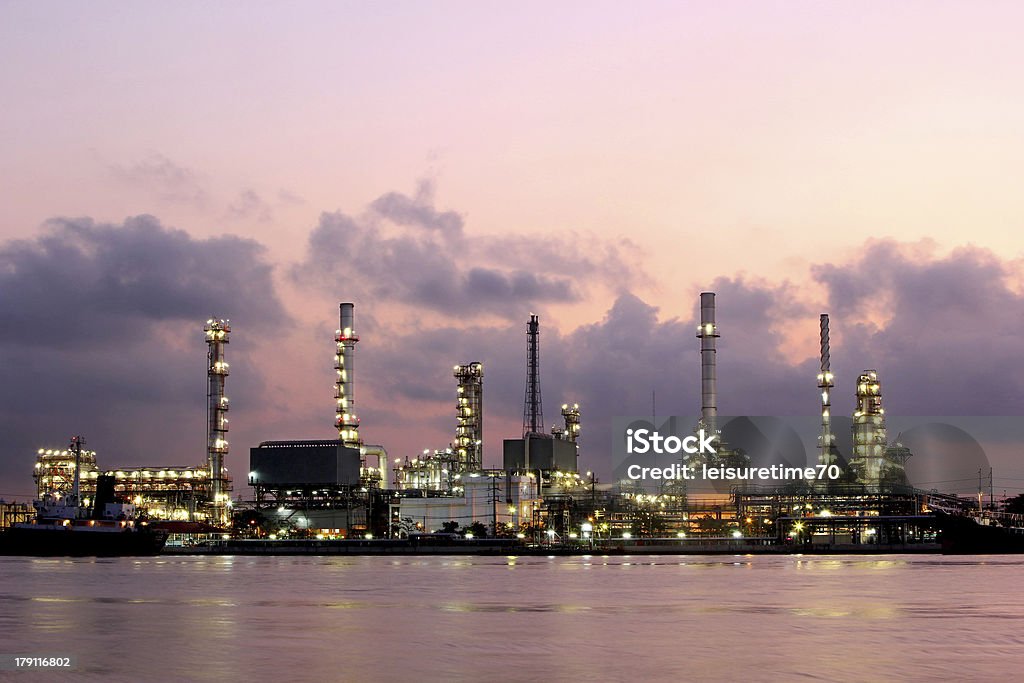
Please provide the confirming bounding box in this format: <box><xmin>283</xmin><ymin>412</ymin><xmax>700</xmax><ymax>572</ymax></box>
<box><xmin>0</xmin><ymin>555</ymin><xmax>1024</xmax><ymax>681</ymax></box>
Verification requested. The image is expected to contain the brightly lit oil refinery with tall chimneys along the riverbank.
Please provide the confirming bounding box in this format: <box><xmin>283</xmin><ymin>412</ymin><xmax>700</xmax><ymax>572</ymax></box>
<box><xmin>14</xmin><ymin>292</ymin><xmax>964</xmax><ymax>547</ymax></box>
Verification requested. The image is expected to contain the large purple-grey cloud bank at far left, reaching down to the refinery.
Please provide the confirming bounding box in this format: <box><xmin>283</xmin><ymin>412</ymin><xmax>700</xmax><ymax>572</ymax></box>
<box><xmin>0</xmin><ymin>216</ymin><xmax>289</xmax><ymax>495</ymax></box>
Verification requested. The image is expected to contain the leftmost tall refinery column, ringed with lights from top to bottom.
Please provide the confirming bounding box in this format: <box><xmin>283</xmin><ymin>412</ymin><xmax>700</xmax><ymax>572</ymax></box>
<box><xmin>203</xmin><ymin>317</ymin><xmax>231</xmax><ymax>525</ymax></box>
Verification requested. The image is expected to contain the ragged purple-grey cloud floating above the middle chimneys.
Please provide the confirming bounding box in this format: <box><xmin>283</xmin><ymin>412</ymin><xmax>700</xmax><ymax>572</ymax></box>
<box><xmin>292</xmin><ymin>184</ymin><xmax>643</xmax><ymax>319</ymax></box>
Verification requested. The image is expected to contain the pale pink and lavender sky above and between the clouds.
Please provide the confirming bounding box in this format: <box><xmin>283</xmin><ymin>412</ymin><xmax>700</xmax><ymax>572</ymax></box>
<box><xmin>0</xmin><ymin>1</ymin><xmax>1024</xmax><ymax>493</ymax></box>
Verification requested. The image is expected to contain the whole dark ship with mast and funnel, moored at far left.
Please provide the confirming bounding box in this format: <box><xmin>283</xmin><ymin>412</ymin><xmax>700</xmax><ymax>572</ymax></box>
<box><xmin>0</xmin><ymin>437</ymin><xmax>167</xmax><ymax>557</ymax></box>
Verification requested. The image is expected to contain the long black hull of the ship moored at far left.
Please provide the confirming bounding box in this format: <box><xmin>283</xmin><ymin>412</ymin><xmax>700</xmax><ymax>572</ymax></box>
<box><xmin>0</xmin><ymin>526</ymin><xmax>167</xmax><ymax>557</ymax></box>
